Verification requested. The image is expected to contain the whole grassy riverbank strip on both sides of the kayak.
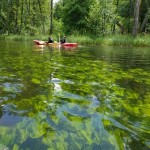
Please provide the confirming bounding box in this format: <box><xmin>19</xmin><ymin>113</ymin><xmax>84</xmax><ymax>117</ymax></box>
<box><xmin>0</xmin><ymin>35</ymin><xmax>150</xmax><ymax>47</ymax></box>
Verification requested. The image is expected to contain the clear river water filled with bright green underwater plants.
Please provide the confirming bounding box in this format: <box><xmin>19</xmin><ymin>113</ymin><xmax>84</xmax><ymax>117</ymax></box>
<box><xmin>0</xmin><ymin>41</ymin><xmax>150</xmax><ymax>150</ymax></box>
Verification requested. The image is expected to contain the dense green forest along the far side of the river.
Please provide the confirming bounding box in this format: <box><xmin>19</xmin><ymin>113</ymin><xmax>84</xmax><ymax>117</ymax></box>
<box><xmin>0</xmin><ymin>0</ymin><xmax>150</xmax><ymax>36</ymax></box>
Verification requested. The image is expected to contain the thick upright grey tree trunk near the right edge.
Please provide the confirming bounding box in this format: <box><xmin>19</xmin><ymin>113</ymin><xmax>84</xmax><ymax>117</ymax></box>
<box><xmin>132</xmin><ymin>0</ymin><xmax>141</xmax><ymax>37</ymax></box>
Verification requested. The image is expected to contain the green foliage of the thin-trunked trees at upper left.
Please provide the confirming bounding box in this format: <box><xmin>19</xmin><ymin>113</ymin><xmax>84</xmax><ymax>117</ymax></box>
<box><xmin>0</xmin><ymin>0</ymin><xmax>49</xmax><ymax>35</ymax></box>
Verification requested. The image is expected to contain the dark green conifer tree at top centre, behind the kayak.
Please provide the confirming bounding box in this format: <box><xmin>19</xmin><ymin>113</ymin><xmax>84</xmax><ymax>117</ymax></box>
<box><xmin>62</xmin><ymin>0</ymin><xmax>92</xmax><ymax>33</ymax></box>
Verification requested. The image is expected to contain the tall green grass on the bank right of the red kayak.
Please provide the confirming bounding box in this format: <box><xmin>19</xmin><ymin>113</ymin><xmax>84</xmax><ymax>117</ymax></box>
<box><xmin>69</xmin><ymin>35</ymin><xmax>150</xmax><ymax>47</ymax></box>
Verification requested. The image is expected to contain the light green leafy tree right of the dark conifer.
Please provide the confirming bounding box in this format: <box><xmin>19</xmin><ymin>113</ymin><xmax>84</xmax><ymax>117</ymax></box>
<box><xmin>87</xmin><ymin>0</ymin><xmax>116</xmax><ymax>35</ymax></box>
